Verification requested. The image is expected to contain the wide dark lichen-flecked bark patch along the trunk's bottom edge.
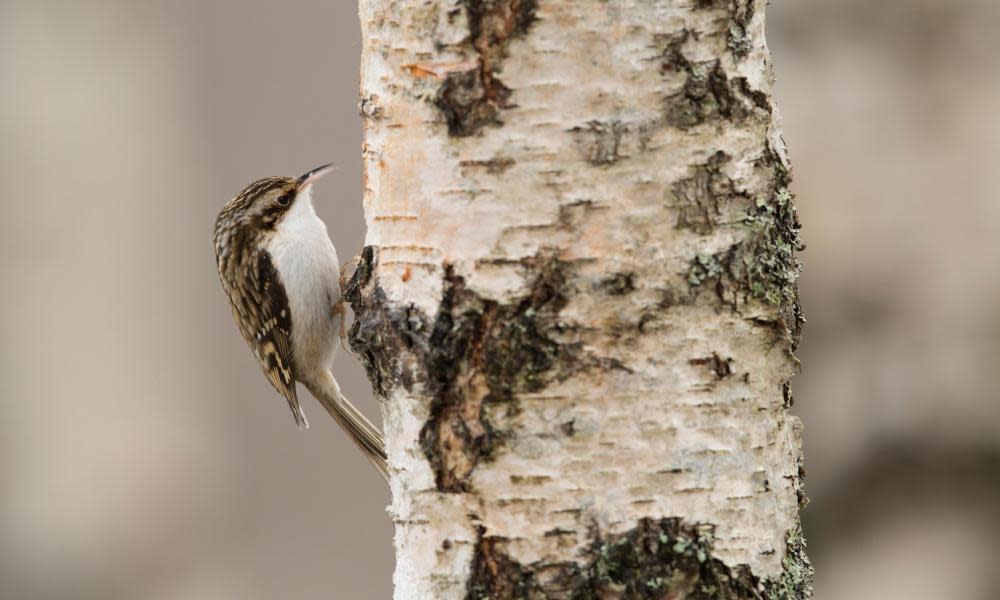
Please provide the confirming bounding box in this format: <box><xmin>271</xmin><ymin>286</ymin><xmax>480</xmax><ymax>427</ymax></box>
<box><xmin>466</xmin><ymin>519</ymin><xmax>812</xmax><ymax>600</ymax></box>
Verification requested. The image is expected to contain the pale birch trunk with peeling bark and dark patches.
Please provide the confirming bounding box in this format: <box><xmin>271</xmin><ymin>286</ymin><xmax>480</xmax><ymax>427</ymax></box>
<box><xmin>348</xmin><ymin>0</ymin><xmax>812</xmax><ymax>599</ymax></box>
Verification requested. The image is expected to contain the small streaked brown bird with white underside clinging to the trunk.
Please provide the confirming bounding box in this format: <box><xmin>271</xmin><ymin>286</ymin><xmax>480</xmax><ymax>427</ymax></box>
<box><xmin>214</xmin><ymin>164</ymin><xmax>388</xmax><ymax>481</ymax></box>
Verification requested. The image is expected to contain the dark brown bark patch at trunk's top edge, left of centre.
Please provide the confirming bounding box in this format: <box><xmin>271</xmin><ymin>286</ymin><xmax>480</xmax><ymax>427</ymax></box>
<box><xmin>435</xmin><ymin>0</ymin><xmax>537</xmax><ymax>137</ymax></box>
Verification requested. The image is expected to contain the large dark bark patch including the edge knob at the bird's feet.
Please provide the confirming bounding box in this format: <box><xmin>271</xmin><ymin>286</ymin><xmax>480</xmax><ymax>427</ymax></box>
<box><xmin>345</xmin><ymin>247</ymin><xmax>626</xmax><ymax>492</ymax></box>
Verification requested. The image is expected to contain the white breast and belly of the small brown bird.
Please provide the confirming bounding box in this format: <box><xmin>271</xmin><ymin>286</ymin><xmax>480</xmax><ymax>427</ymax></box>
<box><xmin>267</xmin><ymin>189</ymin><xmax>340</xmax><ymax>379</ymax></box>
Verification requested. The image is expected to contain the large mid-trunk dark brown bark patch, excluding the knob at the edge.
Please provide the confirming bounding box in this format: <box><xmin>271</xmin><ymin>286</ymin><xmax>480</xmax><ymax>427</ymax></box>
<box><xmin>420</xmin><ymin>255</ymin><xmax>623</xmax><ymax>492</ymax></box>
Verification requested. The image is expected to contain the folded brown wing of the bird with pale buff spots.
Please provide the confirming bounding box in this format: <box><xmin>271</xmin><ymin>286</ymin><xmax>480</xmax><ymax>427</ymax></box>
<box><xmin>244</xmin><ymin>250</ymin><xmax>309</xmax><ymax>428</ymax></box>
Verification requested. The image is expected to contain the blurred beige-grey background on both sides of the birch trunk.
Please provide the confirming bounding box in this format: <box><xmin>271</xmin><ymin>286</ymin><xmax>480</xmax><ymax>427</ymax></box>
<box><xmin>0</xmin><ymin>0</ymin><xmax>1000</xmax><ymax>600</ymax></box>
